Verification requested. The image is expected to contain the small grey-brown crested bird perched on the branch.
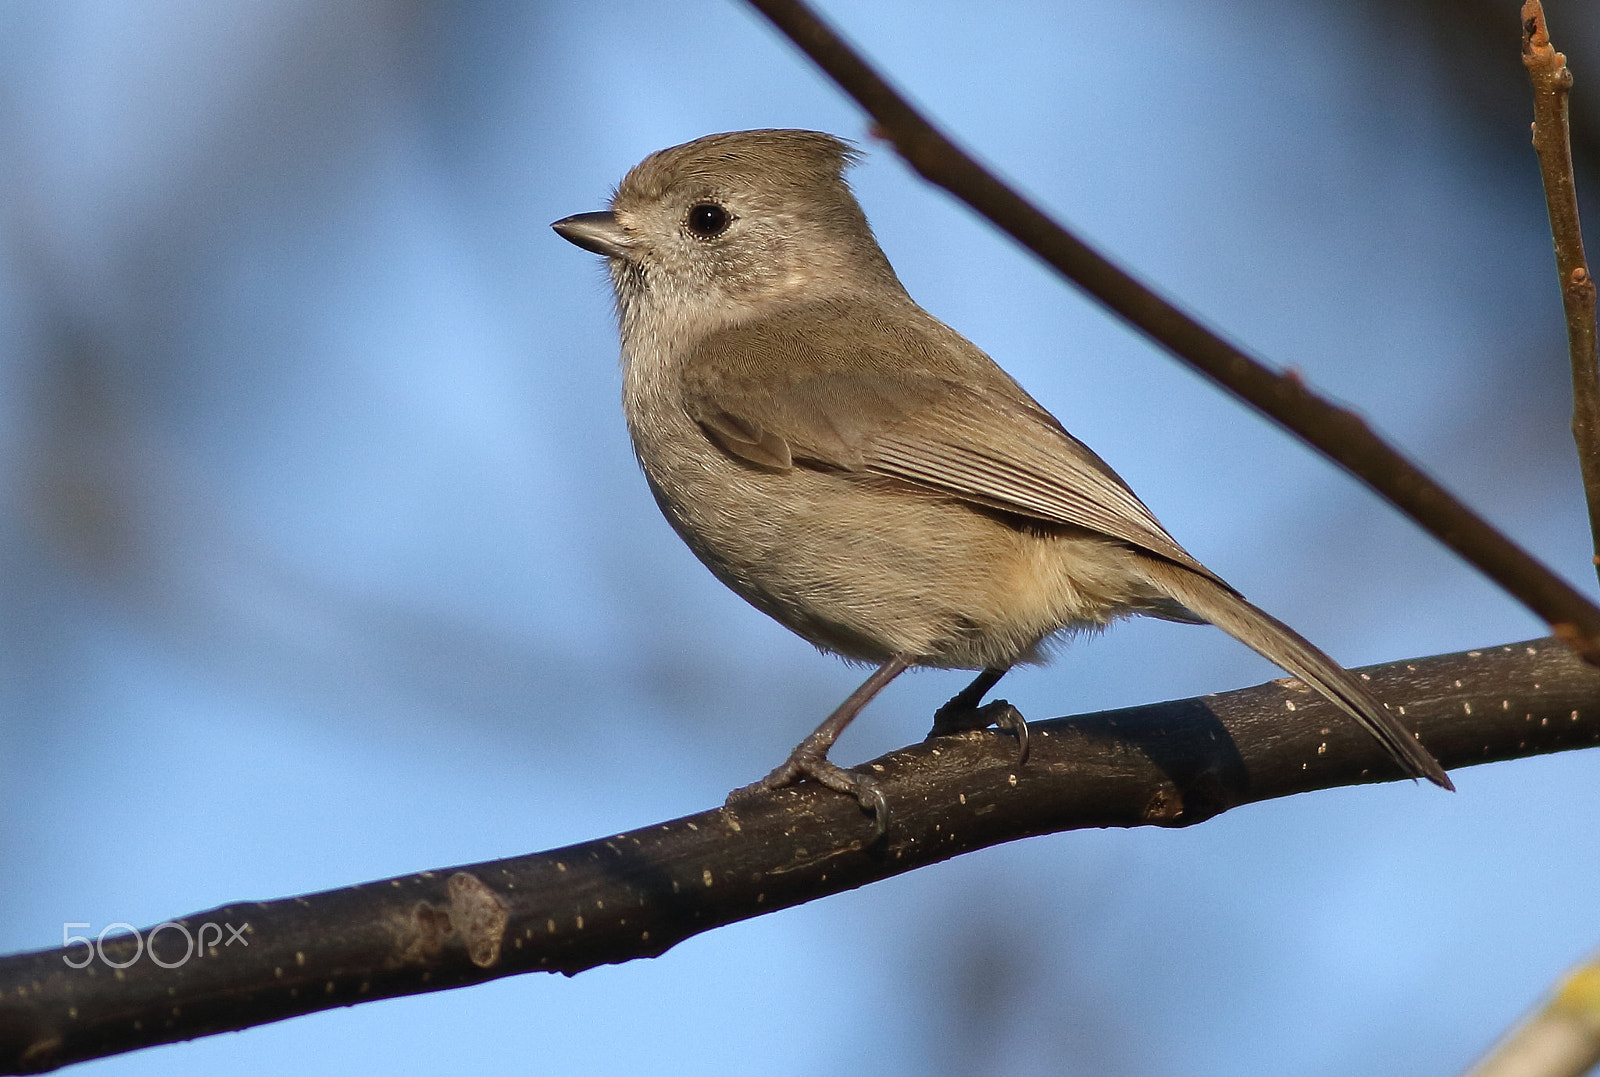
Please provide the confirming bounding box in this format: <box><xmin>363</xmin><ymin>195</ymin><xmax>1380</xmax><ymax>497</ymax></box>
<box><xmin>552</xmin><ymin>131</ymin><xmax>1451</xmax><ymax>826</ymax></box>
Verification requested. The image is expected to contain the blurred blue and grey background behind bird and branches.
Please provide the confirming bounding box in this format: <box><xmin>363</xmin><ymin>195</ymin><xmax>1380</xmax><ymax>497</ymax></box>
<box><xmin>0</xmin><ymin>0</ymin><xmax>1600</xmax><ymax>1075</ymax></box>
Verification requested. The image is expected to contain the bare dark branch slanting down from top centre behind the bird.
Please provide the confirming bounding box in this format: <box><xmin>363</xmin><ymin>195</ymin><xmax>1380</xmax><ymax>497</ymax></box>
<box><xmin>749</xmin><ymin>0</ymin><xmax>1600</xmax><ymax>664</ymax></box>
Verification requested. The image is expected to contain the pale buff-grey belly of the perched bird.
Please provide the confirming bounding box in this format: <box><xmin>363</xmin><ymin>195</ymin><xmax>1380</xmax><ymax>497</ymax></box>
<box><xmin>627</xmin><ymin>416</ymin><xmax>1154</xmax><ymax>669</ymax></box>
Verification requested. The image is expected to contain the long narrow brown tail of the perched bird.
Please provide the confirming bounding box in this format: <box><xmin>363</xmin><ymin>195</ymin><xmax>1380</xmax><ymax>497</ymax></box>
<box><xmin>1142</xmin><ymin>557</ymin><xmax>1454</xmax><ymax>791</ymax></box>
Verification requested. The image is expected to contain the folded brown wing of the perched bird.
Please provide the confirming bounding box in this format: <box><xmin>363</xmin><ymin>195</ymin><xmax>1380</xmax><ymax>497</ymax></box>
<box><xmin>682</xmin><ymin>302</ymin><xmax>1226</xmax><ymax>586</ymax></box>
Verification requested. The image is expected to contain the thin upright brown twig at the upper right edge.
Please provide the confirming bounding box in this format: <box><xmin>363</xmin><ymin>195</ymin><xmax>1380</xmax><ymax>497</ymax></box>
<box><xmin>1522</xmin><ymin>0</ymin><xmax>1600</xmax><ymax>588</ymax></box>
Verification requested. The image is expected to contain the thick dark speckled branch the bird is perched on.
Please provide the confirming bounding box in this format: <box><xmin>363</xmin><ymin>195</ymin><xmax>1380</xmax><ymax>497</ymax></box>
<box><xmin>0</xmin><ymin>640</ymin><xmax>1600</xmax><ymax>1074</ymax></box>
